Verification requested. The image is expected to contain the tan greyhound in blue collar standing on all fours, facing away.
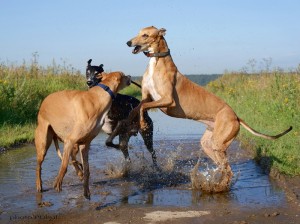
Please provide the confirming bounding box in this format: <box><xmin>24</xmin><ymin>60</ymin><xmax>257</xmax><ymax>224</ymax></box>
<box><xmin>35</xmin><ymin>72</ymin><xmax>131</xmax><ymax>198</ymax></box>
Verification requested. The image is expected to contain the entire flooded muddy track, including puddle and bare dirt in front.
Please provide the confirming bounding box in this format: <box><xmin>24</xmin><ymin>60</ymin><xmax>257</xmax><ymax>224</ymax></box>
<box><xmin>0</xmin><ymin>112</ymin><xmax>300</xmax><ymax>223</ymax></box>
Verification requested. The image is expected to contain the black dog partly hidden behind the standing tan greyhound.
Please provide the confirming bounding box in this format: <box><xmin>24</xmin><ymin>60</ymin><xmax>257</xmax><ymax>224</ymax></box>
<box><xmin>86</xmin><ymin>59</ymin><xmax>157</xmax><ymax>165</ymax></box>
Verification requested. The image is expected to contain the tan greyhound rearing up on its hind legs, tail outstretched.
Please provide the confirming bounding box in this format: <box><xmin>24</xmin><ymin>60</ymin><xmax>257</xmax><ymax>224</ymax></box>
<box><xmin>127</xmin><ymin>26</ymin><xmax>292</xmax><ymax>191</ymax></box>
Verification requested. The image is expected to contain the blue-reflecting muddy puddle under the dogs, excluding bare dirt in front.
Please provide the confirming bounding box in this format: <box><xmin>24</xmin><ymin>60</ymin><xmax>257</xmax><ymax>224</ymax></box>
<box><xmin>0</xmin><ymin>112</ymin><xmax>287</xmax><ymax>222</ymax></box>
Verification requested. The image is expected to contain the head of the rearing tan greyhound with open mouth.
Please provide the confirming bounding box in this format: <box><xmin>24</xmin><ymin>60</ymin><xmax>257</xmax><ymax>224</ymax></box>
<box><xmin>127</xmin><ymin>26</ymin><xmax>166</xmax><ymax>54</ymax></box>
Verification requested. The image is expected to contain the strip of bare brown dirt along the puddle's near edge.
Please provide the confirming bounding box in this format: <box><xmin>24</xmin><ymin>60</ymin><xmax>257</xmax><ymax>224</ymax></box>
<box><xmin>8</xmin><ymin>201</ymin><xmax>300</xmax><ymax>224</ymax></box>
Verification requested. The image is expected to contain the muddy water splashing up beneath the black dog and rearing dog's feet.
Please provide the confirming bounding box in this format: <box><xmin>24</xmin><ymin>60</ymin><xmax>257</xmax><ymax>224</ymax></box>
<box><xmin>105</xmin><ymin>145</ymin><xmax>238</xmax><ymax>193</ymax></box>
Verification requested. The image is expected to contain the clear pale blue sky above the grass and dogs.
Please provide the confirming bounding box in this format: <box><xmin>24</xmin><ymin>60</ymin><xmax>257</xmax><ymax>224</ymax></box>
<box><xmin>0</xmin><ymin>0</ymin><xmax>300</xmax><ymax>76</ymax></box>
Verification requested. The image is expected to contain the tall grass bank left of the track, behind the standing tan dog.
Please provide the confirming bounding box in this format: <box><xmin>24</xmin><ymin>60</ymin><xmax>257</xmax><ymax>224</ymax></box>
<box><xmin>0</xmin><ymin>63</ymin><xmax>86</xmax><ymax>147</ymax></box>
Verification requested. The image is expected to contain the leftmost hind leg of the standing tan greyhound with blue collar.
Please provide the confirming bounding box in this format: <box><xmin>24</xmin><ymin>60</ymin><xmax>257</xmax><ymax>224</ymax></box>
<box><xmin>35</xmin><ymin>119</ymin><xmax>54</xmax><ymax>192</ymax></box>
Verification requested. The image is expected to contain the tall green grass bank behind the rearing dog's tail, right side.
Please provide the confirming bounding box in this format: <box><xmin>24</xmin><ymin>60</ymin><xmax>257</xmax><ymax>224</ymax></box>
<box><xmin>207</xmin><ymin>71</ymin><xmax>300</xmax><ymax>175</ymax></box>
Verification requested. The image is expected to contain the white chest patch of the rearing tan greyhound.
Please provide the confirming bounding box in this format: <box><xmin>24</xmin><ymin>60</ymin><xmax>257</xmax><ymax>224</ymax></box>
<box><xmin>143</xmin><ymin>58</ymin><xmax>161</xmax><ymax>101</ymax></box>
